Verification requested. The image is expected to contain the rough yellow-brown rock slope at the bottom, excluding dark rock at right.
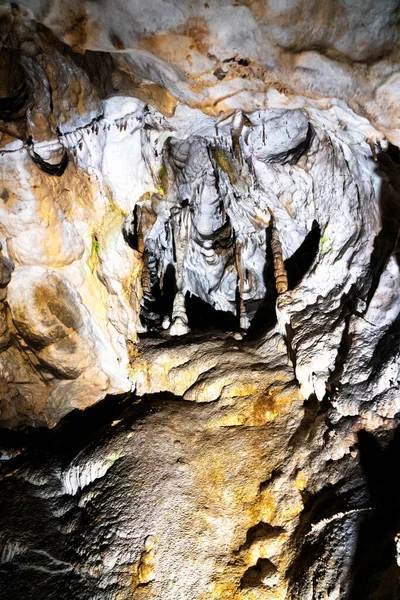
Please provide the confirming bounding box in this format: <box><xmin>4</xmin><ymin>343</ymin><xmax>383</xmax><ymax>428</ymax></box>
<box><xmin>0</xmin><ymin>345</ymin><xmax>356</xmax><ymax>599</ymax></box>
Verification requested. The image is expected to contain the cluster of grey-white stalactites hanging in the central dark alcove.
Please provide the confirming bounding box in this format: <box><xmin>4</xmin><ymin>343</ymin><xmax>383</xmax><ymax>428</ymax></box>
<box><xmin>130</xmin><ymin>111</ymin><xmax>312</xmax><ymax>335</ymax></box>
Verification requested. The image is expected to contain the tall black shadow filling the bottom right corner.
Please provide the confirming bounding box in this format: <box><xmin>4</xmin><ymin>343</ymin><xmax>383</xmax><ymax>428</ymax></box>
<box><xmin>347</xmin><ymin>427</ymin><xmax>400</xmax><ymax>600</ymax></box>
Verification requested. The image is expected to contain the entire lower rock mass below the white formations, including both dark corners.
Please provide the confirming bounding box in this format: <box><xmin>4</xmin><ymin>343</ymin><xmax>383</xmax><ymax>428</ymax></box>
<box><xmin>0</xmin><ymin>358</ymin><xmax>400</xmax><ymax>600</ymax></box>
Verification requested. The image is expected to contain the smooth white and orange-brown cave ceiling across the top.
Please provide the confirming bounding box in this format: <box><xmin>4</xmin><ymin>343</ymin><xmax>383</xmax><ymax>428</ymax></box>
<box><xmin>0</xmin><ymin>0</ymin><xmax>399</xmax><ymax>143</ymax></box>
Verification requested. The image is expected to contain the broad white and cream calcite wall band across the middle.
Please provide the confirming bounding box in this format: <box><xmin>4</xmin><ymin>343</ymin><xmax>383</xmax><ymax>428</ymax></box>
<box><xmin>1</xmin><ymin>86</ymin><xmax>398</xmax><ymax>422</ymax></box>
